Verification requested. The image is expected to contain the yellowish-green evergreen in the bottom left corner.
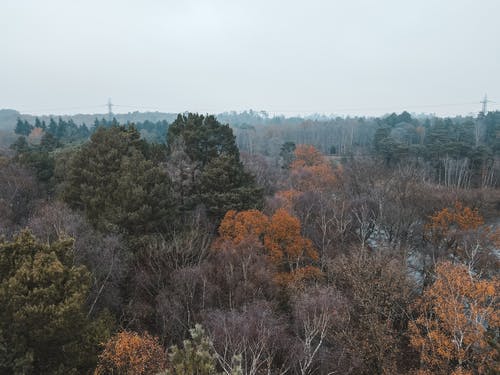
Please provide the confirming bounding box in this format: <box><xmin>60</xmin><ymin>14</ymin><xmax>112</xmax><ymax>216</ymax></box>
<box><xmin>0</xmin><ymin>231</ymin><xmax>112</xmax><ymax>375</ymax></box>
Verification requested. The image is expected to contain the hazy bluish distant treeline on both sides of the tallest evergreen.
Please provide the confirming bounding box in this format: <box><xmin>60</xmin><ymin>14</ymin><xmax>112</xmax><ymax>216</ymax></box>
<box><xmin>9</xmin><ymin>111</ymin><xmax>500</xmax><ymax>187</ymax></box>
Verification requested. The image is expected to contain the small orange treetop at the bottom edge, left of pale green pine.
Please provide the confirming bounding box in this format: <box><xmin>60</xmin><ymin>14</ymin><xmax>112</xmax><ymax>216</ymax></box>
<box><xmin>94</xmin><ymin>331</ymin><xmax>166</xmax><ymax>375</ymax></box>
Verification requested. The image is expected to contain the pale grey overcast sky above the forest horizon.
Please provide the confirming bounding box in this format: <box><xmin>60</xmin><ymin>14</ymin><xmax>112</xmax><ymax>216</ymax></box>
<box><xmin>0</xmin><ymin>0</ymin><xmax>500</xmax><ymax>115</ymax></box>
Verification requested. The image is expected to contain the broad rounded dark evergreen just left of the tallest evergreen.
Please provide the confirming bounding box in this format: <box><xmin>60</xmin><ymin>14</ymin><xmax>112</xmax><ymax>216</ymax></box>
<box><xmin>64</xmin><ymin>126</ymin><xmax>175</xmax><ymax>234</ymax></box>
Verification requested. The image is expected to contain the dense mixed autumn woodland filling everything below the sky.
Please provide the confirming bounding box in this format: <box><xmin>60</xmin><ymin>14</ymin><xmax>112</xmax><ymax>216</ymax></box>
<box><xmin>0</xmin><ymin>112</ymin><xmax>500</xmax><ymax>375</ymax></box>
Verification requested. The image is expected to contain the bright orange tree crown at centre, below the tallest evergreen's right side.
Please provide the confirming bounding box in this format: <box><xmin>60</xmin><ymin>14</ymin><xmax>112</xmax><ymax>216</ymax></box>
<box><xmin>216</xmin><ymin>209</ymin><xmax>320</xmax><ymax>283</ymax></box>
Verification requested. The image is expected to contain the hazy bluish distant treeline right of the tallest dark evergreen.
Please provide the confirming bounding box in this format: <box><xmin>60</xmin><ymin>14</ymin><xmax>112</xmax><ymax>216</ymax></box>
<box><xmin>234</xmin><ymin>111</ymin><xmax>500</xmax><ymax>187</ymax></box>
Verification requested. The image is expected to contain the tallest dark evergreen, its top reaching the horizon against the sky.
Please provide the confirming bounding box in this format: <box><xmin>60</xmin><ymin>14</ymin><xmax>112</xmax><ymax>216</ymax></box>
<box><xmin>167</xmin><ymin>113</ymin><xmax>263</xmax><ymax>219</ymax></box>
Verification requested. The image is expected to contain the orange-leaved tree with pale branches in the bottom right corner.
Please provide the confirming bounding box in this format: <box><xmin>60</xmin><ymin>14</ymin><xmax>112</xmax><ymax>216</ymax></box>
<box><xmin>409</xmin><ymin>262</ymin><xmax>500</xmax><ymax>375</ymax></box>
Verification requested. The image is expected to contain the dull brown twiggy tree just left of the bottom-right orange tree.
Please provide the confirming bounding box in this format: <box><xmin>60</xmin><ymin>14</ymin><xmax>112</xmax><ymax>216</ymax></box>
<box><xmin>328</xmin><ymin>249</ymin><xmax>414</xmax><ymax>375</ymax></box>
